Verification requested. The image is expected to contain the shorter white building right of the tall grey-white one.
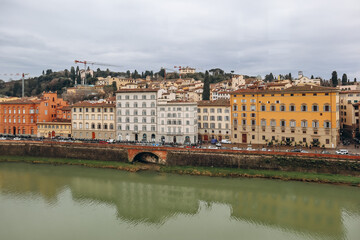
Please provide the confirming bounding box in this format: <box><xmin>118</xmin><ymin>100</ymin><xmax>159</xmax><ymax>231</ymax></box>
<box><xmin>157</xmin><ymin>101</ymin><xmax>198</xmax><ymax>144</ymax></box>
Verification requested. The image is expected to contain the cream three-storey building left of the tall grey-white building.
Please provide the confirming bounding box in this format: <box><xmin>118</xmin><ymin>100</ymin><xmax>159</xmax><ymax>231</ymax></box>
<box><xmin>71</xmin><ymin>101</ymin><xmax>115</xmax><ymax>140</ymax></box>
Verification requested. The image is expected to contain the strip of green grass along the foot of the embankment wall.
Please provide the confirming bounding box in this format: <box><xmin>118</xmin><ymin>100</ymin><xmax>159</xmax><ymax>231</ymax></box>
<box><xmin>0</xmin><ymin>156</ymin><xmax>360</xmax><ymax>187</ymax></box>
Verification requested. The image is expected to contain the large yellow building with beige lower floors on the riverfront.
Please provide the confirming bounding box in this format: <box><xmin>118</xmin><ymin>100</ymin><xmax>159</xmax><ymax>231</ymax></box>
<box><xmin>230</xmin><ymin>86</ymin><xmax>339</xmax><ymax>148</ymax></box>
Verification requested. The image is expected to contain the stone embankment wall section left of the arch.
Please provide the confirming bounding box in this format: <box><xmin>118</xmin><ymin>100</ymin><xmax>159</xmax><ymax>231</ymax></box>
<box><xmin>0</xmin><ymin>143</ymin><xmax>128</xmax><ymax>162</ymax></box>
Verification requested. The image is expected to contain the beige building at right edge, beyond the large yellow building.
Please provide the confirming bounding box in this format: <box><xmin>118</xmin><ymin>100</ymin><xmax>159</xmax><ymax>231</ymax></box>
<box><xmin>339</xmin><ymin>90</ymin><xmax>360</xmax><ymax>137</ymax></box>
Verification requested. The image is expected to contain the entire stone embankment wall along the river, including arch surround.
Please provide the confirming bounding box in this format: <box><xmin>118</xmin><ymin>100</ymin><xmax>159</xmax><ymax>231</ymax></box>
<box><xmin>0</xmin><ymin>142</ymin><xmax>360</xmax><ymax>176</ymax></box>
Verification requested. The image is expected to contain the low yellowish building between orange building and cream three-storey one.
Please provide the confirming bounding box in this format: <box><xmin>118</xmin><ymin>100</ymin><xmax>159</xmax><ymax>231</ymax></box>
<box><xmin>36</xmin><ymin>119</ymin><xmax>71</xmax><ymax>138</ymax></box>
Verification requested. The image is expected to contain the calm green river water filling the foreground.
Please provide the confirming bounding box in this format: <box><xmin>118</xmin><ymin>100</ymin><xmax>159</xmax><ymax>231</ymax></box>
<box><xmin>0</xmin><ymin>163</ymin><xmax>360</xmax><ymax>240</ymax></box>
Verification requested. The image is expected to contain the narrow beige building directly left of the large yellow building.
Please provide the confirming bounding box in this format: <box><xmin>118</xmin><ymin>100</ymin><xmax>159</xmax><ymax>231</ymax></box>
<box><xmin>198</xmin><ymin>99</ymin><xmax>231</xmax><ymax>142</ymax></box>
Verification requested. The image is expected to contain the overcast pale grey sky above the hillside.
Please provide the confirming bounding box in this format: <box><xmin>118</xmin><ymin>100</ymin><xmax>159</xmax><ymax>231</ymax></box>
<box><xmin>0</xmin><ymin>0</ymin><xmax>360</xmax><ymax>80</ymax></box>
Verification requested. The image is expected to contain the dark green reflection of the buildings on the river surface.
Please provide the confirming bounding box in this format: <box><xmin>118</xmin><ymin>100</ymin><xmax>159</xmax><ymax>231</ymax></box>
<box><xmin>0</xmin><ymin>164</ymin><xmax>360</xmax><ymax>239</ymax></box>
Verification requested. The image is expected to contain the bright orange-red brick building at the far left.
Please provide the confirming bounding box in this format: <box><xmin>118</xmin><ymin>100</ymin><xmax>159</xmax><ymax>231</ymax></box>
<box><xmin>0</xmin><ymin>92</ymin><xmax>67</xmax><ymax>135</ymax></box>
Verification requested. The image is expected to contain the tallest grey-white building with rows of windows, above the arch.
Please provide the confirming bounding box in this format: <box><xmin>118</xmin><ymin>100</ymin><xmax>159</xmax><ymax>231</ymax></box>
<box><xmin>116</xmin><ymin>88</ymin><xmax>158</xmax><ymax>142</ymax></box>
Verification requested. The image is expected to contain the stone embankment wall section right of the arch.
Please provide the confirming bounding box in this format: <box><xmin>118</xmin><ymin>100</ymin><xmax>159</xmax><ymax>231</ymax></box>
<box><xmin>167</xmin><ymin>150</ymin><xmax>360</xmax><ymax>176</ymax></box>
